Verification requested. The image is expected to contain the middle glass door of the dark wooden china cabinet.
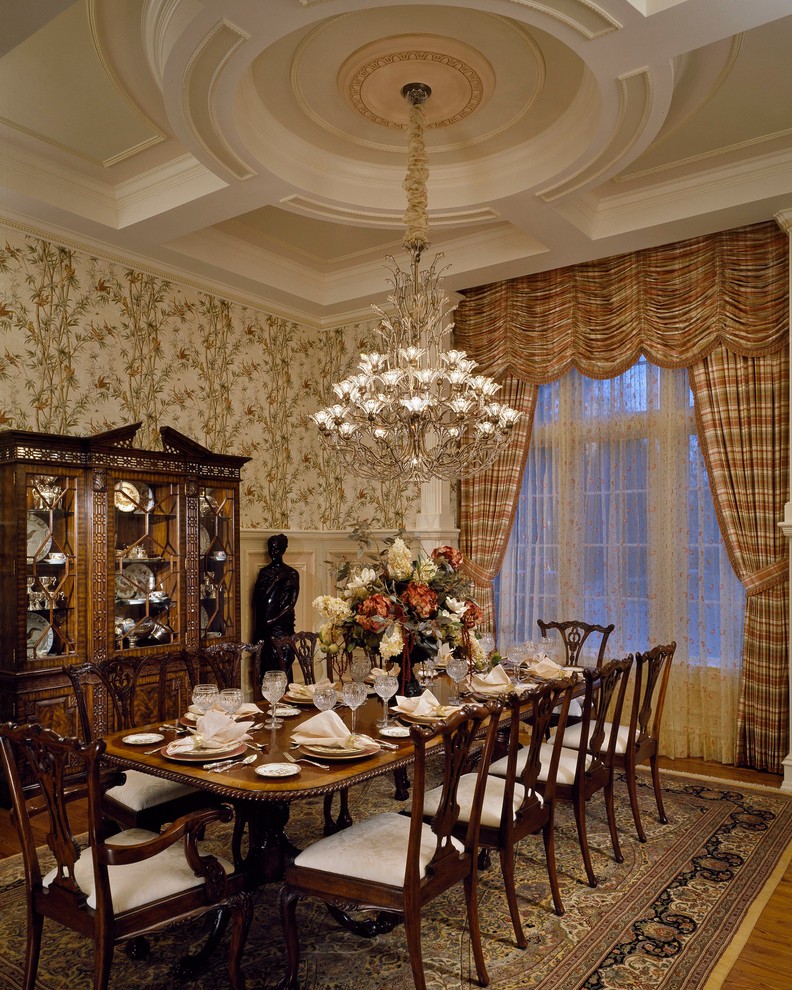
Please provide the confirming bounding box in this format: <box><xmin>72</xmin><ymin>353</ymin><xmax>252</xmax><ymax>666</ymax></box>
<box><xmin>113</xmin><ymin>478</ymin><xmax>181</xmax><ymax>651</ymax></box>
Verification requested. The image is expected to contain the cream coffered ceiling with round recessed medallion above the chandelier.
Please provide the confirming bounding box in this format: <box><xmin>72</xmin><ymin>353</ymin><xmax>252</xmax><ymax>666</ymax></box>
<box><xmin>0</xmin><ymin>0</ymin><xmax>792</xmax><ymax>325</ymax></box>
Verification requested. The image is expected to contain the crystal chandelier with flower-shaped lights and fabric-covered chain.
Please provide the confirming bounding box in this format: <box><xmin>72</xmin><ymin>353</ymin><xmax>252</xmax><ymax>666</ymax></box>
<box><xmin>311</xmin><ymin>83</ymin><xmax>520</xmax><ymax>481</ymax></box>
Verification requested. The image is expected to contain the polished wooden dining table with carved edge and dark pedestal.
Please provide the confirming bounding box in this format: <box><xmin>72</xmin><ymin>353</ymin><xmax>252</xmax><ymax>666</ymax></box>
<box><xmin>104</xmin><ymin>689</ymin><xmax>434</xmax><ymax>889</ymax></box>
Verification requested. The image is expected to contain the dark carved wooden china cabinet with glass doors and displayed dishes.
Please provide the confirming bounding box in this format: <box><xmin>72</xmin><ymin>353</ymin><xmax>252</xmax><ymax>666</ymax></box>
<box><xmin>0</xmin><ymin>424</ymin><xmax>248</xmax><ymax>800</ymax></box>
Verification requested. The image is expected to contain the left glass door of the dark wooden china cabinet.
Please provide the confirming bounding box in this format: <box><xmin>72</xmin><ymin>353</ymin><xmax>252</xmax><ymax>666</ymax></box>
<box><xmin>25</xmin><ymin>474</ymin><xmax>77</xmax><ymax>660</ymax></box>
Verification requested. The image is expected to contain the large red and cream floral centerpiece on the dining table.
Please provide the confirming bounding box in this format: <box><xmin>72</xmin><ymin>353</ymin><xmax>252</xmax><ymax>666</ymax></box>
<box><xmin>313</xmin><ymin>536</ymin><xmax>486</xmax><ymax>693</ymax></box>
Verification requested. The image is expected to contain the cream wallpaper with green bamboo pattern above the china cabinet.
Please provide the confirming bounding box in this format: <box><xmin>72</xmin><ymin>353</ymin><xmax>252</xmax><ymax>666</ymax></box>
<box><xmin>0</xmin><ymin>224</ymin><xmax>418</xmax><ymax>530</ymax></box>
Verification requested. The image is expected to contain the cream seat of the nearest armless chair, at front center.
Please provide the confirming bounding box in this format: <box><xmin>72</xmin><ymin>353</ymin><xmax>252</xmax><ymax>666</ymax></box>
<box><xmin>294</xmin><ymin>811</ymin><xmax>465</xmax><ymax>887</ymax></box>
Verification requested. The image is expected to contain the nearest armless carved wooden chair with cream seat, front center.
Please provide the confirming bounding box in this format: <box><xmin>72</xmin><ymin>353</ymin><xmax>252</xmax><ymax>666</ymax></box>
<box><xmin>278</xmin><ymin>701</ymin><xmax>500</xmax><ymax>990</ymax></box>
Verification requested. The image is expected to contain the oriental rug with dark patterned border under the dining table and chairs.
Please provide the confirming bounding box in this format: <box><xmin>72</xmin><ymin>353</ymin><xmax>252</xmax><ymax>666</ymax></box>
<box><xmin>0</xmin><ymin>772</ymin><xmax>792</xmax><ymax>990</ymax></box>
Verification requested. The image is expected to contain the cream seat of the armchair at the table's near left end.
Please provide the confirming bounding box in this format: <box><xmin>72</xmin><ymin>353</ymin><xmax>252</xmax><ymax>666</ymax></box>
<box><xmin>42</xmin><ymin>828</ymin><xmax>234</xmax><ymax>914</ymax></box>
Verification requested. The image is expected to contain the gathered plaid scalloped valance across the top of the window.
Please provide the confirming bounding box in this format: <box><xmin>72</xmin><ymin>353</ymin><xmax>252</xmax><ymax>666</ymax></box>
<box><xmin>454</xmin><ymin>221</ymin><xmax>789</xmax><ymax>384</ymax></box>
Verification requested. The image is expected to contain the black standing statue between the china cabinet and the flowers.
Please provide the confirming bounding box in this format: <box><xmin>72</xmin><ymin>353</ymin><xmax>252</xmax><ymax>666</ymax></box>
<box><xmin>253</xmin><ymin>533</ymin><xmax>300</xmax><ymax>678</ymax></box>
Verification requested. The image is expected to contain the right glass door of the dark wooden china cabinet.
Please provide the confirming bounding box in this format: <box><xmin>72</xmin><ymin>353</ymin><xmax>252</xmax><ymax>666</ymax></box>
<box><xmin>198</xmin><ymin>487</ymin><xmax>236</xmax><ymax>640</ymax></box>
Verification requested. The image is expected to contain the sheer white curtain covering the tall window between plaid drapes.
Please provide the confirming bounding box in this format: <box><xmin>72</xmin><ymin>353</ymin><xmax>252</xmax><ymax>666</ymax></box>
<box><xmin>496</xmin><ymin>360</ymin><xmax>745</xmax><ymax>763</ymax></box>
